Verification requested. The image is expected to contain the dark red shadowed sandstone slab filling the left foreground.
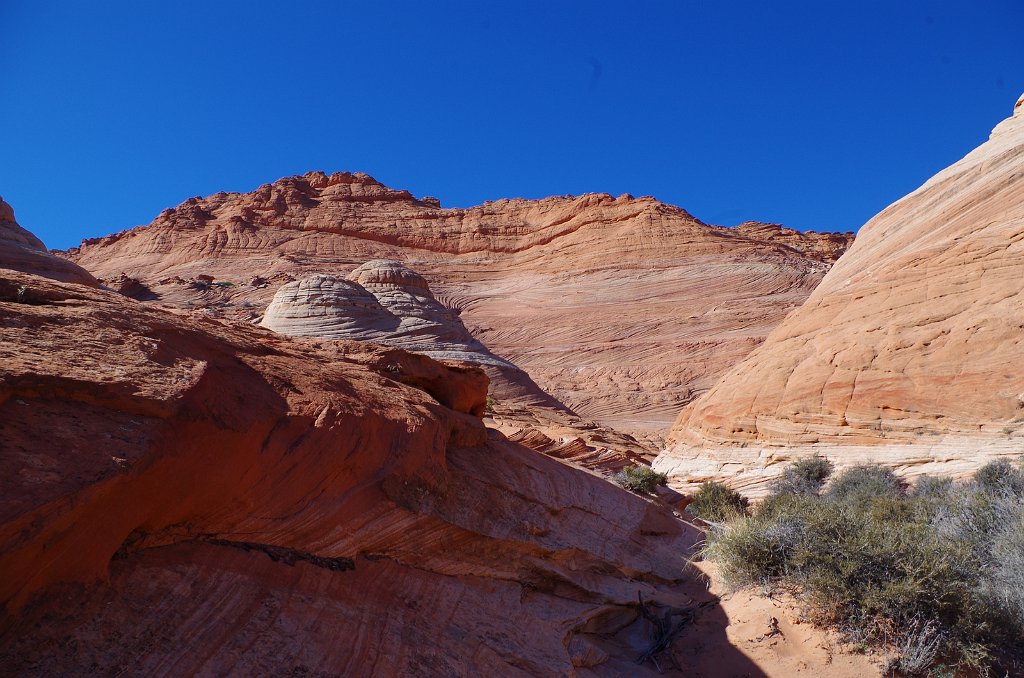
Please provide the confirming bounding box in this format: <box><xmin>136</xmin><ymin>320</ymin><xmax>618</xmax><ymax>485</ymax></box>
<box><xmin>0</xmin><ymin>271</ymin><xmax>720</xmax><ymax>676</ymax></box>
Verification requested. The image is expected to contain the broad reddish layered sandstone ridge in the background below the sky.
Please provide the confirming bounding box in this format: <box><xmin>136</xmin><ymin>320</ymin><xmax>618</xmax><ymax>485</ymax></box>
<box><xmin>61</xmin><ymin>180</ymin><xmax>852</xmax><ymax>439</ymax></box>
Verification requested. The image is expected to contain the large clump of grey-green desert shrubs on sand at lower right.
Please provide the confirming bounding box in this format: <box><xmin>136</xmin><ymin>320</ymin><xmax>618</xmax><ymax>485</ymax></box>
<box><xmin>702</xmin><ymin>463</ymin><xmax>1024</xmax><ymax>675</ymax></box>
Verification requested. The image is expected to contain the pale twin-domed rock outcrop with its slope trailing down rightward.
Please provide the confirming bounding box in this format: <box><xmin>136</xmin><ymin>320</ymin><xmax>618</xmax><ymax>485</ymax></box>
<box><xmin>260</xmin><ymin>259</ymin><xmax>654</xmax><ymax>472</ymax></box>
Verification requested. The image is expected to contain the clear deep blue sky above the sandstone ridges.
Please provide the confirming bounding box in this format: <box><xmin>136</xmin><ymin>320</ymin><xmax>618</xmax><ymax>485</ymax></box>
<box><xmin>0</xmin><ymin>0</ymin><xmax>1024</xmax><ymax>248</ymax></box>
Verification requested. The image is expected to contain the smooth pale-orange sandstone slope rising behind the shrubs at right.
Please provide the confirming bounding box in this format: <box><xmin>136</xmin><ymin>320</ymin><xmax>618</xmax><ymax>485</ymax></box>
<box><xmin>657</xmin><ymin>91</ymin><xmax>1024</xmax><ymax>492</ymax></box>
